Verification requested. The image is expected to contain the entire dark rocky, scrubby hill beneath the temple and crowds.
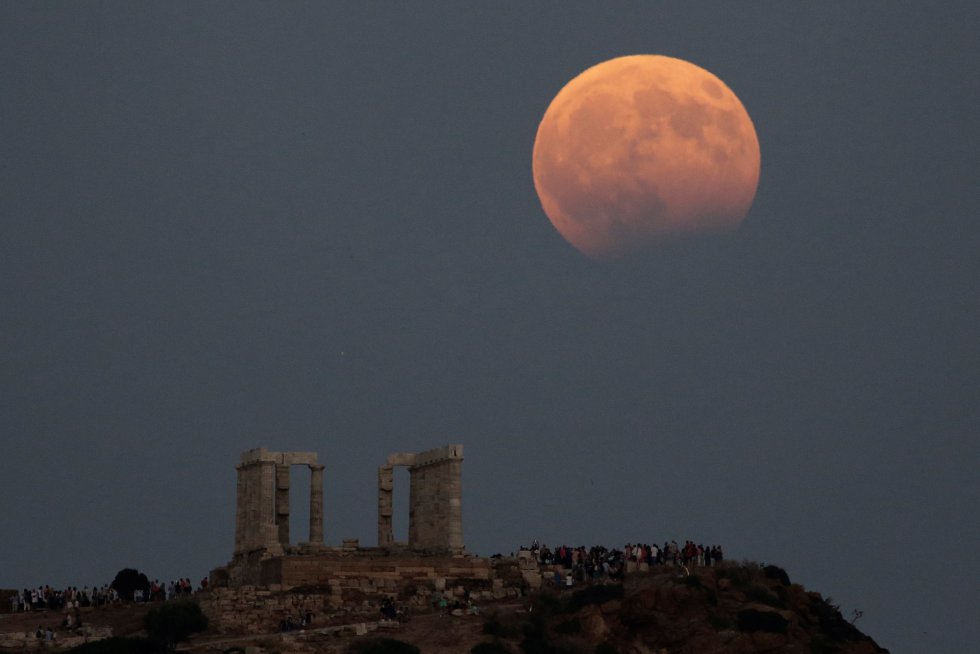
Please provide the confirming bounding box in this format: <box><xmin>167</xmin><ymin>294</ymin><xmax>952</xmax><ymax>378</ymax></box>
<box><xmin>0</xmin><ymin>559</ymin><xmax>887</xmax><ymax>654</ymax></box>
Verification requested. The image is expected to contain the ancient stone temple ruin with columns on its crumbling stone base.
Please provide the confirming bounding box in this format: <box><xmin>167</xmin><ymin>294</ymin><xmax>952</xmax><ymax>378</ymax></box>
<box><xmin>207</xmin><ymin>445</ymin><xmax>542</xmax><ymax>633</ymax></box>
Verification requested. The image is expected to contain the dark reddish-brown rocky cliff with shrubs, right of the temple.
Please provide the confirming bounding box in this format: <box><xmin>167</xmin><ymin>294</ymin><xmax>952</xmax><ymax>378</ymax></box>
<box><xmin>489</xmin><ymin>564</ymin><xmax>886</xmax><ymax>654</ymax></box>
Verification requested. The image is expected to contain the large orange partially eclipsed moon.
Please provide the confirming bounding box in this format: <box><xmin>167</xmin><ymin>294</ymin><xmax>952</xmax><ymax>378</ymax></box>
<box><xmin>533</xmin><ymin>55</ymin><xmax>759</xmax><ymax>261</ymax></box>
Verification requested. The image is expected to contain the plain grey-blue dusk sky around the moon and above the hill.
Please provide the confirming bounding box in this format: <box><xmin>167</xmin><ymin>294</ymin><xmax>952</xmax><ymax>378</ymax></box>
<box><xmin>0</xmin><ymin>2</ymin><xmax>980</xmax><ymax>653</ymax></box>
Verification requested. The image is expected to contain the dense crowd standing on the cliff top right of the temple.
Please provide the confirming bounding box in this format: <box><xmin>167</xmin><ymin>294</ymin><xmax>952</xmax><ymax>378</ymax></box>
<box><xmin>520</xmin><ymin>540</ymin><xmax>724</xmax><ymax>585</ymax></box>
